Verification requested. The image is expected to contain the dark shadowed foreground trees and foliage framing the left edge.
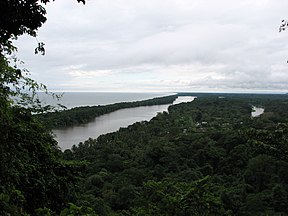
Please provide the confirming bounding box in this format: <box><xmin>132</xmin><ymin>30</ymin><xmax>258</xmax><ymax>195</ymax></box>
<box><xmin>0</xmin><ymin>0</ymin><xmax>84</xmax><ymax>215</ymax></box>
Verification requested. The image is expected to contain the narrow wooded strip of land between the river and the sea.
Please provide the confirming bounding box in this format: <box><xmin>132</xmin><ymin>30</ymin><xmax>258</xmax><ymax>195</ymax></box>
<box><xmin>37</xmin><ymin>94</ymin><xmax>178</xmax><ymax>129</ymax></box>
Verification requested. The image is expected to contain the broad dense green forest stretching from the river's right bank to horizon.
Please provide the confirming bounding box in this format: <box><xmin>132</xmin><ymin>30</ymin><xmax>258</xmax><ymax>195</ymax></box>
<box><xmin>64</xmin><ymin>95</ymin><xmax>288</xmax><ymax>215</ymax></box>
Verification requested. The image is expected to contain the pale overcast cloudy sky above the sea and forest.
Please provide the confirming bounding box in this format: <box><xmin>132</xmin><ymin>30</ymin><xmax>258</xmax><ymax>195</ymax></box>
<box><xmin>15</xmin><ymin>0</ymin><xmax>288</xmax><ymax>93</ymax></box>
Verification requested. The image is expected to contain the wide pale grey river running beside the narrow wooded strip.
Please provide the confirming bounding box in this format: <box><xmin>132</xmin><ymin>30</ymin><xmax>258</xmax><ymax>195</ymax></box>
<box><xmin>53</xmin><ymin>96</ymin><xmax>195</xmax><ymax>150</ymax></box>
